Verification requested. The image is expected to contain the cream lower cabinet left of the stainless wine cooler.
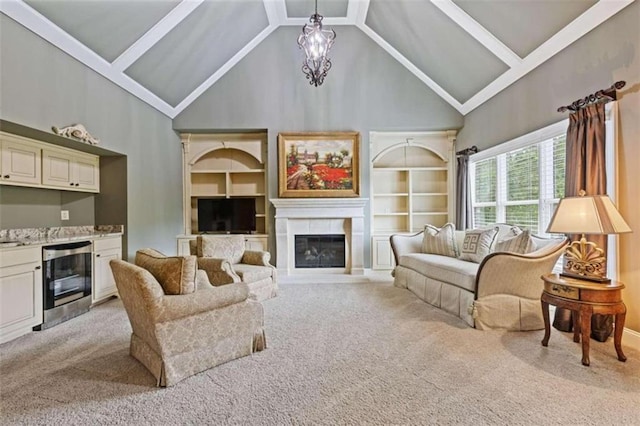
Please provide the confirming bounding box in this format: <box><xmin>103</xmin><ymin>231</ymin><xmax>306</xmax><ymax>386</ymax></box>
<box><xmin>0</xmin><ymin>246</ymin><xmax>43</xmax><ymax>343</ymax></box>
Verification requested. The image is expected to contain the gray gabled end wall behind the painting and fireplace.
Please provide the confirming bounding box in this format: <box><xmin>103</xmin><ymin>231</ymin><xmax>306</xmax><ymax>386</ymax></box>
<box><xmin>173</xmin><ymin>27</ymin><xmax>462</xmax><ymax>266</ymax></box>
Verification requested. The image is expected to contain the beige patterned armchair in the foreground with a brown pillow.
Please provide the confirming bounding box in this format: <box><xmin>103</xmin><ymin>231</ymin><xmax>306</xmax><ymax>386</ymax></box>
<box><xmin>110</xmin><ymin>249</ymin><xmax>266</xmax><ymax>386</ymax></box>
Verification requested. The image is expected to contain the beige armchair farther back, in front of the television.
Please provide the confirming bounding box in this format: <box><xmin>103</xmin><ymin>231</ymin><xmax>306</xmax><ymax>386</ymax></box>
<box><xmin>189</xmin><ymin>235</ymin><xmax>278</xmax><ymax>301</ymax></box>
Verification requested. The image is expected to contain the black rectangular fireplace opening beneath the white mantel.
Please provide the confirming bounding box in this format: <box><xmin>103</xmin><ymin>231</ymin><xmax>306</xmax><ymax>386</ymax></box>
<box><xmin>295</xmin><ymin>234</ymin><xmax>345</xmax><ymax>268</ymax></box>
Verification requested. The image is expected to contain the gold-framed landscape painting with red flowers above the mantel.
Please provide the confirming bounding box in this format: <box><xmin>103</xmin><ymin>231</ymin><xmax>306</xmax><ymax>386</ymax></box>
<box><xmin>278</xmin><ymin>132</ymin><xmax>360</xmax><ymax>198</ymax></box>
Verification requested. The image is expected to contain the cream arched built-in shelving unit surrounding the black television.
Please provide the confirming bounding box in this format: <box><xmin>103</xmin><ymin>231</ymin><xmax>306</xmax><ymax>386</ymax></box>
<box><xmin>178</xmin><ymin>132</ymin><xmax>269</xmax><ymax>255</ymax></box>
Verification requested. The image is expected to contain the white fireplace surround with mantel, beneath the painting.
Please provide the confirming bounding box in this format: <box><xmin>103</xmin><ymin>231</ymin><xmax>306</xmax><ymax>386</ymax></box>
<box><xmin>271</xmin><ymin>198</ymin><xmax>369</xmax><ymax>276</ymax></box>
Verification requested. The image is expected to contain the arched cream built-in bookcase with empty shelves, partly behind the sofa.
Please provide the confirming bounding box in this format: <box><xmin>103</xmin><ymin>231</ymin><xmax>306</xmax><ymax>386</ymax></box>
<box><xmin>369</xmin><ymin>131</ymin><xmax>456</xmax><ymax>269</ymax></box>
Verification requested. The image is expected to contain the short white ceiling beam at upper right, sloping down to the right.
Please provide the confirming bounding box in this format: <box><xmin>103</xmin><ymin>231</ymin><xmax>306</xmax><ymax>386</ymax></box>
<box><xmin>431</xmin><ymin>0</ymin><xmax>522</xmax><ymax>67</ymax></box>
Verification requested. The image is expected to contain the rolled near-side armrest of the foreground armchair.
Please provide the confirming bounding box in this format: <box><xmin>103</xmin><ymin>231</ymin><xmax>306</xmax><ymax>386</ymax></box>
<box><xmin>155</xmin><ymin>283</ymin><xmax>249</xmax><ymax>323</ymax></box>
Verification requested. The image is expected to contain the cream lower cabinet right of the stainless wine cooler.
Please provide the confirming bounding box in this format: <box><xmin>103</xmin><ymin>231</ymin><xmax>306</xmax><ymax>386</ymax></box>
<box><xmin>91</xmin><ymin>236</ymin><xmax>122</xmax><ymax>303</ymax></box>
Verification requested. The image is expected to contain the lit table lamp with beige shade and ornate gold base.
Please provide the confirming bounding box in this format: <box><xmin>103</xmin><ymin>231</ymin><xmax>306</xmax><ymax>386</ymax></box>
<box><xmin>547</xmin><ymin>190</ymin><xmax>631</xmax><ymax>282</ymax></box>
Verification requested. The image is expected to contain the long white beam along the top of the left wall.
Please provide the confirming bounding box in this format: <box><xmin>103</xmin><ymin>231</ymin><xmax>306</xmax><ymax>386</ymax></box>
<box><xmin>0</xmin><ymin>0</ymin><xmax>173</xmax><ymax>117</ymax></box>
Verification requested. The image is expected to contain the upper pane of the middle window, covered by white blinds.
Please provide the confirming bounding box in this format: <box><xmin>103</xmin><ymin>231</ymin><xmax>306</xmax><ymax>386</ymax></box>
<box><xmin>506</xmin><ymin>144</ymin><xmax>540</xmax><ymax>201</ymax></box>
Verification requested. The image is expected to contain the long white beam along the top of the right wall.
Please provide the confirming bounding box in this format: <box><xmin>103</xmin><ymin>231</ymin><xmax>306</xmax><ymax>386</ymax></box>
<box><xmin>460</xmin><ymin>0</ymin><xmax>635</xmax><ymax>115</ymax></box>
